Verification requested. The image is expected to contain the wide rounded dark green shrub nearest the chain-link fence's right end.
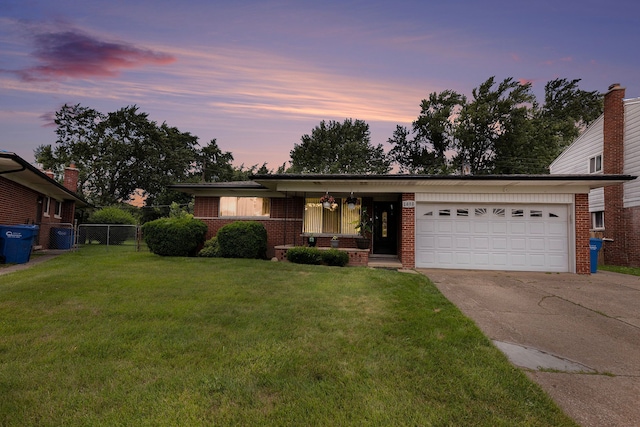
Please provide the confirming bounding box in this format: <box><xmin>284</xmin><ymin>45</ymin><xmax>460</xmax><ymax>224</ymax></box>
<box><xmin>142</xmin><ymin>217</ymin><xmax>207</xmax><ymax>256</ymax></box>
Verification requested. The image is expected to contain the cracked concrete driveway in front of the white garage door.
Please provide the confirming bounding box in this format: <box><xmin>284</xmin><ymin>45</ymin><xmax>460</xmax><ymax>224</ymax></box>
<box><xmin>419</xmin><ymin>269</ymin><xmax>640</xmax><ymax>427</ymax></box>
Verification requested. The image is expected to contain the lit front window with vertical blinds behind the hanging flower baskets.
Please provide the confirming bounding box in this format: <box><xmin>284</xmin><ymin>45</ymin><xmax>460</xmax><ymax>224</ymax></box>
<box><xmin>303</xmin><ymin>197</ymin><xmax>362</xmax><ymax>234</ymax></box>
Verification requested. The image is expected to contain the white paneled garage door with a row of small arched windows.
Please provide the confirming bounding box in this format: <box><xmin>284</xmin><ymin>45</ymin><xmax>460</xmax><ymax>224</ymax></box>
<box><xmin>416</xmin><ymin>203</ymin><xmax>569</xmax><ymax>272</ymax></box>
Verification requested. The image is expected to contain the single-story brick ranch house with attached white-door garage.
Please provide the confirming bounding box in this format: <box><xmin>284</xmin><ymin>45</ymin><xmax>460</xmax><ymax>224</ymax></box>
<box><xmin>171</xmin><ymin>174</ymin><xmax>634</xmax><ymax>274</ymax></box>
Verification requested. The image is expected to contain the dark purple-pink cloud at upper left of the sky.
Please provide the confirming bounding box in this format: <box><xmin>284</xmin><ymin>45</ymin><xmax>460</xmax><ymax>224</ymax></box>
<box><xmin>16</xmin><ymin>30</ymin><xmax>175</xmax><ymax>81</ymax></box>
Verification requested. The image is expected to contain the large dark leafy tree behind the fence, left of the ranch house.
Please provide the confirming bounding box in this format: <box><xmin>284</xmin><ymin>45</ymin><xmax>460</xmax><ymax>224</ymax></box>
<box><xmin>35</xmin><ymin>104</ymin><xmax>198</xmax><ymax>206</ymax></box>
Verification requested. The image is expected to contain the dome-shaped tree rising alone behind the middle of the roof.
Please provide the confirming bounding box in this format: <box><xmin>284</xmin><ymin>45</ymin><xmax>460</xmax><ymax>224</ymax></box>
<box><xmin>288</xmin><ymin>119</ymin><xmax>391</xmax><ymax>174</ymax></box>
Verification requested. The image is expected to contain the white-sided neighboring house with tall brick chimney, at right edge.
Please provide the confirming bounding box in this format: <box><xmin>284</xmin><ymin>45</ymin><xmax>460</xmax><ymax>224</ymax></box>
<box><xmin>550</xmin><ymin>83</ymin><xmax>640</xmax><ymax>267</ymax></box>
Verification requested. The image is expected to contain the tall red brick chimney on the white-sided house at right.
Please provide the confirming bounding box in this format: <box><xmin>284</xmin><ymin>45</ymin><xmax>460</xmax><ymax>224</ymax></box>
<box><xmin>602</xmin><ymin>83</ymin><xmax>628</xmax><ymax>265</ymax></box>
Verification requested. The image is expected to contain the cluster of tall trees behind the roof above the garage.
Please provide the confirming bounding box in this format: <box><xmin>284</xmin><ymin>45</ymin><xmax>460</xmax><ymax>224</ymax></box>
<box><xmin>389</xmin><ymin>77</ymin><xmax>602</xmax><ymax>174</ymax></box>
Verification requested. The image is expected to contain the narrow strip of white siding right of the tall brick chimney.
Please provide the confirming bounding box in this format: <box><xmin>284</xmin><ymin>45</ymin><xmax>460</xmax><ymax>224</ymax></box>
<box><xmin>624</xmin><ymin>98</ymin><xmax>640</xmax><ymax>207</ymax></box>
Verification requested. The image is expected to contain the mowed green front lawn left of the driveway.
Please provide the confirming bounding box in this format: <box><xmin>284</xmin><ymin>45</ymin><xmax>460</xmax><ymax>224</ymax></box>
<box><xmin>0</xmin><ymin>248</ymin><xmax>575</xmax><ymax>426</ymax></box>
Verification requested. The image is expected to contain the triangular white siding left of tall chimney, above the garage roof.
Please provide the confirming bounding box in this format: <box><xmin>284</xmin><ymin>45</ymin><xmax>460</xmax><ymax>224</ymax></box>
<box><xmin>549</xmin><ymin>116</ymin><xmax>604</xmax><ymax>174</ymax></box>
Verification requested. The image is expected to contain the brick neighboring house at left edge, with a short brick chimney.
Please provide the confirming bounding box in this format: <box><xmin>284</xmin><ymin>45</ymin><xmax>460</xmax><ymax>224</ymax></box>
<box><xmin>0</xmin><ymin>151</ymin><xmax>89</xmax><ymax>249</ymax></box>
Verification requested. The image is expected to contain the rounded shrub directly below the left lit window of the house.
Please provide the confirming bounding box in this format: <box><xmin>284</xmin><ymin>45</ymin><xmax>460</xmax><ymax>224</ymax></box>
<box><xmin>216</xmin><ymin>221</ymin><xmax>267</xmax><ymax>259</ymax></box>
